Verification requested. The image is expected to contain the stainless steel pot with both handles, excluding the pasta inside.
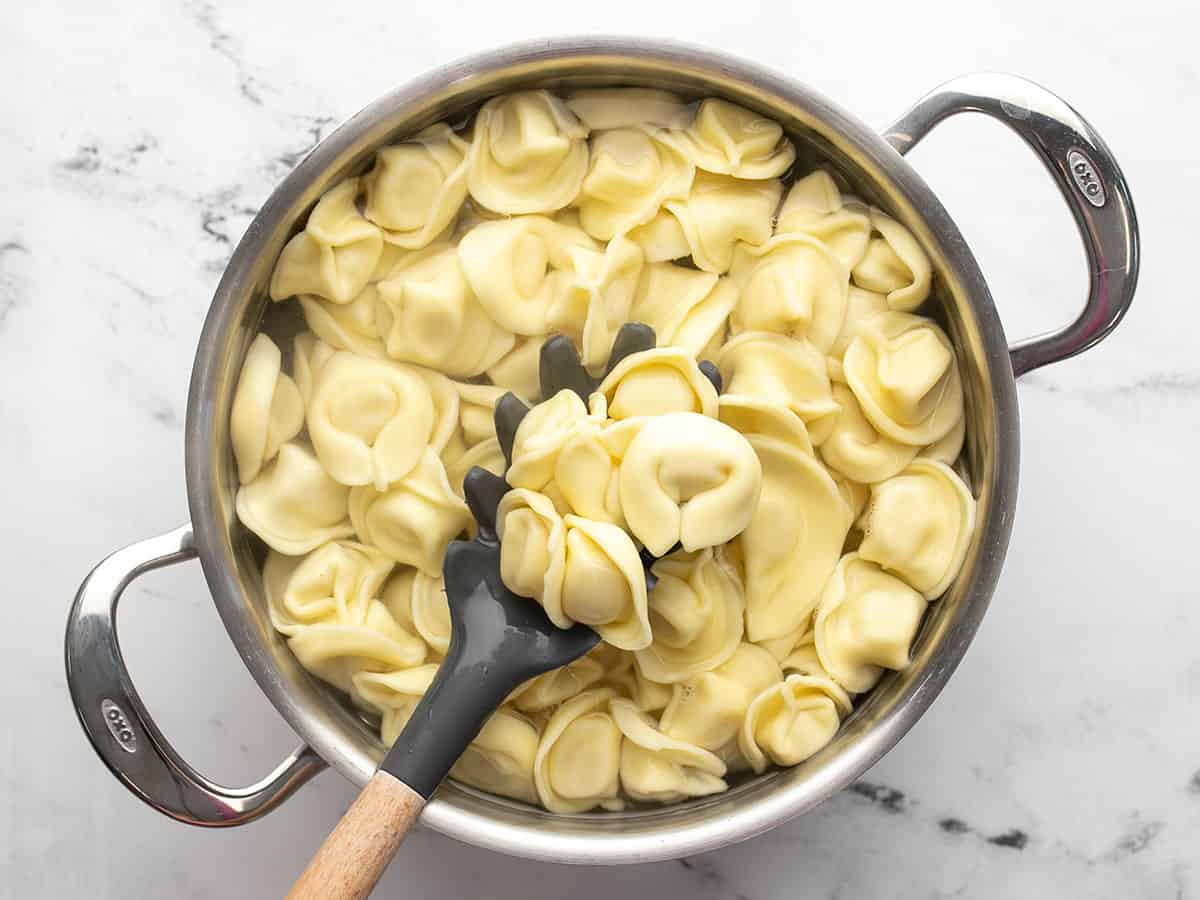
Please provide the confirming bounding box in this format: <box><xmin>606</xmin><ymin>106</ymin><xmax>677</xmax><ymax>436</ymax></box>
<box><xmin>66</xmin><ymin>38</ymin><xmax>1138</xmax><ymax>864</ymax></box>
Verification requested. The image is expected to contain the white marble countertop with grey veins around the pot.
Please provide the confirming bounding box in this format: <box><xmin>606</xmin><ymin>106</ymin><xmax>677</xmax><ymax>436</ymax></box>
<box><xmin>0</xmin><ymin>0</ymin><xmax>1200</xmax><ymax>900</ymax></box>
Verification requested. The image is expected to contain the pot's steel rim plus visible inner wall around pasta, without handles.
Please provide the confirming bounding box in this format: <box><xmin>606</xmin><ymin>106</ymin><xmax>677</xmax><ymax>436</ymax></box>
<box><xmin>187</xmin><ymin>40</ymin><xmax>1018</xmax><ymax>863</ymax></box>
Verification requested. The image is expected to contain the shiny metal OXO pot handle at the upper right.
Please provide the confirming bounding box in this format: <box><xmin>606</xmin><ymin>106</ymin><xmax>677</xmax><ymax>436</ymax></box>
<box><xmin>883</xmin><ymin>73</ymin><xmax>1139</xmax><ymax>376</ymax></box>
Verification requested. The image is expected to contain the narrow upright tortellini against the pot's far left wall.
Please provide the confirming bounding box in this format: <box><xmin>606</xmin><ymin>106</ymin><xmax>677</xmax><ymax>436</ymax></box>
<box><xmin>229</xmin><ymin>335</ymin><xmax>304</xmax><ymax>485</ymax></box>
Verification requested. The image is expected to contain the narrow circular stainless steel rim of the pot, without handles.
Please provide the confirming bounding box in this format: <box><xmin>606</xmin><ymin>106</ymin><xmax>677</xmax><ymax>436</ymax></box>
<box><xmin>185</xmin><ymin>36</ymin><xmax>1019</xmax><ymax>864</ymax></box>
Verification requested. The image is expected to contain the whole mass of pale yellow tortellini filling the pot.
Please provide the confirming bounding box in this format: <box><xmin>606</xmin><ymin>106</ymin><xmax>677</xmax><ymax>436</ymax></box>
<box><xmin>243</xmin><ymin>88</ymin><xmax>977</xmax><ymax>814</ymax></box>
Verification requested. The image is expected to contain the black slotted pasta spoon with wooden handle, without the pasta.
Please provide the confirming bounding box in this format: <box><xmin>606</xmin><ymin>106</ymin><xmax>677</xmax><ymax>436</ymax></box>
<box><xmin>288</xmin><ymin>323</ymin><xmax>720</xmax><ymax>898</ymax></box>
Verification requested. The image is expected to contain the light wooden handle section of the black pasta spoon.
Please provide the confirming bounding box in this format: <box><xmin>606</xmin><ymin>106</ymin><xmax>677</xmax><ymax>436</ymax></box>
<box><xmin>288</xmin><ymin>769</ymin><xmax>425</xmax><ymax>900</ymax></box>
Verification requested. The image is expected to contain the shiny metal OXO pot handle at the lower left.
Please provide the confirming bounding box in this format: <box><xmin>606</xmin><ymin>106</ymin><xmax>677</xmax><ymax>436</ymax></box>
<box><xmin>66</xmin><ymin>524</ymin><xmax>325</xmax><ymax>827</ymax></box>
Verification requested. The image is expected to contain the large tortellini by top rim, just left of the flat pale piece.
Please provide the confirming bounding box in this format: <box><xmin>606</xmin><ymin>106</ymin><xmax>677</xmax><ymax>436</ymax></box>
<box><xmin>467</xmin><ymin>91</ymin><xmax>588</xmax><ymax>215</ymax></box>
